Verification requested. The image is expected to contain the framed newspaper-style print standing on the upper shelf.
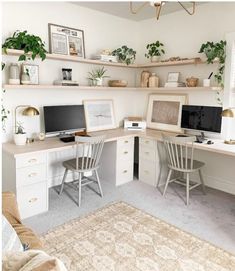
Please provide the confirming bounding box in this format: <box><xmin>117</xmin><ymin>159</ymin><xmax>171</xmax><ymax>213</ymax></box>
<box><xmin>48</xmin><ymin>24</ymin><xmax>85</xmax><ymax>58</ymax></box>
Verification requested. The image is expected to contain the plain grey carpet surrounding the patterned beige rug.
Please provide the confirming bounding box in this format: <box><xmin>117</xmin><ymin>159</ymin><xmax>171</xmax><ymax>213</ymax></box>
<box><xmin>24</xmin><ymin>178</ymin><xmax>235</xmax><ymax>254</ymax></box>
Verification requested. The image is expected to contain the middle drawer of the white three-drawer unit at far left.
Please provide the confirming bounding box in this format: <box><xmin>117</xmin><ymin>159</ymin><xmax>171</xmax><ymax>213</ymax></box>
<box><xmin>16</xmin><ymin>164</ymin><xmax>46</xmax><ymax>187</ymax></box>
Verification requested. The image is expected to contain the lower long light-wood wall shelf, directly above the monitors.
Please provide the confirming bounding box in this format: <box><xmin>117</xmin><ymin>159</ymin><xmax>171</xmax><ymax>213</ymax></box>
<box><xmin>3</xmin><ymin>85</ymin><xmax>221</xmax><ymax>91</ymax></box>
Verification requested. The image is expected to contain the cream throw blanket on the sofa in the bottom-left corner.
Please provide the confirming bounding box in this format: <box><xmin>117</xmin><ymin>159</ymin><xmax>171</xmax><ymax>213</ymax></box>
<box><xmin>2</xmin><ymin>250</ymin><xmax>67</xmax><ymax>271</ymax></box>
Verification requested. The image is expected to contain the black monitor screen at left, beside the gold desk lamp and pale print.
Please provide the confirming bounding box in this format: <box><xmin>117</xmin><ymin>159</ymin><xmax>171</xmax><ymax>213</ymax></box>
<box><xmin>43</xmin><ymin>105</ymin><xmax>86</xmax><ymax>133</ymax></box>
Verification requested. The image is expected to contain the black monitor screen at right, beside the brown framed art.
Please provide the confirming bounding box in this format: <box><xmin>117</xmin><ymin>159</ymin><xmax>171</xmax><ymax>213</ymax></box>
<box><xmin>181</xmin><ymin>105</ymin><xmax>222</xmax><ymax>133</ymax></box>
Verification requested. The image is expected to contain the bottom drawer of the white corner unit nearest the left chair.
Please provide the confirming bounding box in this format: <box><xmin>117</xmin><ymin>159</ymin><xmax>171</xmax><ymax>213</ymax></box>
<box><xmin>116</xmin><ymin>161</ymin><xmax>134</xmax><ymax>185</ymax></box>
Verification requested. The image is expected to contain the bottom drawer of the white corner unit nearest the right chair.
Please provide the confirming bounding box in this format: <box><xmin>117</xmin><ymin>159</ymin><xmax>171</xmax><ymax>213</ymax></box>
<box><xmin>139</xmin><ymin>159</ymin><xmax>156</xmax><ymax>186</ymax></box>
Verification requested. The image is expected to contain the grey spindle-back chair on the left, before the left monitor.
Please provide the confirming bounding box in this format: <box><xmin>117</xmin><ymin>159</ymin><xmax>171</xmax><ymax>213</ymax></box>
<box><xmin>59</xmin><ymin>136</ymin><xmax>104</xmax><ymax>206</ymax></box>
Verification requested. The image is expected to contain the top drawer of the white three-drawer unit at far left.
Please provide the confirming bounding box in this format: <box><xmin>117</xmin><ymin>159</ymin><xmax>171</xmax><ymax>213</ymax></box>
<box><xmin>16</xmin><ymin>153</ymin><xmax>46</xmax><ymax>168</ymax></box>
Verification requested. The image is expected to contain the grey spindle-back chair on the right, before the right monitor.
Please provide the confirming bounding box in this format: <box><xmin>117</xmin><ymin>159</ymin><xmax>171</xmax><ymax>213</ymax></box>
<box><xmin>162</xmin><ymin>135</ymin><xmax>206</xmax><ymax>205</ymax></box>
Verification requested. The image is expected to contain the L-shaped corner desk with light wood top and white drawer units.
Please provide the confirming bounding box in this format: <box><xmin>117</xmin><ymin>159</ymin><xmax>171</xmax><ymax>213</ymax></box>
<box><xmin>2</xmin><ymin>128</ymin><xmax>235</xmax><ymax>218</ymax></box>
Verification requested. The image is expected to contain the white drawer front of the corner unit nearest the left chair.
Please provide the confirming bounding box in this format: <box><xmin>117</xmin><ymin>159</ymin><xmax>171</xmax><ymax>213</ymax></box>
<box><xmin>116</xmin><ymin>137</ymin><xmax>134</xmax><ymax>185</ymax></box>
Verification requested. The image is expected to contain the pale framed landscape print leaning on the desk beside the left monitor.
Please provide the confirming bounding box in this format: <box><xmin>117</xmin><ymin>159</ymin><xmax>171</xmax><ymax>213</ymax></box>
<box><xmin>83</xmin><ymin>100</ymin><xmax>116</xmax><ymax>132</ymax></box>
